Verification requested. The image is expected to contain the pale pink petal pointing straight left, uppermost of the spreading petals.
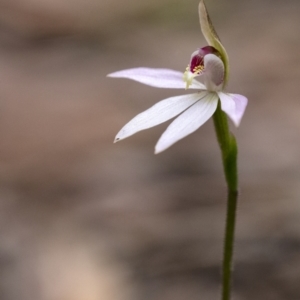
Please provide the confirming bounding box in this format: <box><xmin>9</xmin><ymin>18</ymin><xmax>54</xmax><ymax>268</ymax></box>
<box><xmin>107</xmin><ymin>68</ymin><xmax>205</xmax><ymax>90</ymax></box>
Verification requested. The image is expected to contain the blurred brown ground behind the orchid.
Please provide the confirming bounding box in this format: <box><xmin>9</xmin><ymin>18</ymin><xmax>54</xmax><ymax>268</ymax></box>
<box><xmin>0</xmin><ymin>0</ymin><xmax>300</xmax><ymax>300</ymax></box>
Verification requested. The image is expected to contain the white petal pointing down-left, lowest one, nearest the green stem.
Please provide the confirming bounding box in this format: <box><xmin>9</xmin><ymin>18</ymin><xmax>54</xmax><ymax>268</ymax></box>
<box><xmin>155</xmin><ymin>93</ymin><xmax>219</xmax><ymax>153</ymax></box>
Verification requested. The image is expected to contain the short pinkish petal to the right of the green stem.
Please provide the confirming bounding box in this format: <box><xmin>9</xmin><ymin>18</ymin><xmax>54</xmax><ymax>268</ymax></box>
<box><xmin>218</xmin><ymin>92</ymin><xmax>248</xmax><ymax>126</ymax></box>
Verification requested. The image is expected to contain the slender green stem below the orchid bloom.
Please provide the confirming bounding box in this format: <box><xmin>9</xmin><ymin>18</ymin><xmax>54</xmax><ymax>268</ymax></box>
<box><xmin>213</xmin><ymin>103</ymin><xmax>238</xmax><ymax>300</ymax></box>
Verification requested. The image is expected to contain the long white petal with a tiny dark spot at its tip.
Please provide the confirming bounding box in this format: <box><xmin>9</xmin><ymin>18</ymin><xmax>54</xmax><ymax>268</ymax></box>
<box><xmin>115</xmin><ymin>92</ymin><xmax>206</xmax><ymax>142</ymax></box>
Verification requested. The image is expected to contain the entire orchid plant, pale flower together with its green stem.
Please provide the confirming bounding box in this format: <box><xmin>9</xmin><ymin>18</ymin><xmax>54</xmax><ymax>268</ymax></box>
<box><xmin>108</xmin><ymin>0</ymin><xmax>248</xmax><ymax>300</ymax></box>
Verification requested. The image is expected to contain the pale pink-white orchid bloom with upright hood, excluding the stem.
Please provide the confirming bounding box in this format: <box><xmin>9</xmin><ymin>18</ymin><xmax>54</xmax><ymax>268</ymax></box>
<box><xmin>108</xmin><ymin>0</ymin><xmax>247</xmax><ymax>153</ymax></box>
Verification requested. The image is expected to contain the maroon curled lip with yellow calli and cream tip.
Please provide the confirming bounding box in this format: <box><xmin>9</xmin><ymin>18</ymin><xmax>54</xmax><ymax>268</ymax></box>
<box><xmin>183</xmin><ymin>46</ymin><xmax>220</xmax><ymax>89</ymax></box>
